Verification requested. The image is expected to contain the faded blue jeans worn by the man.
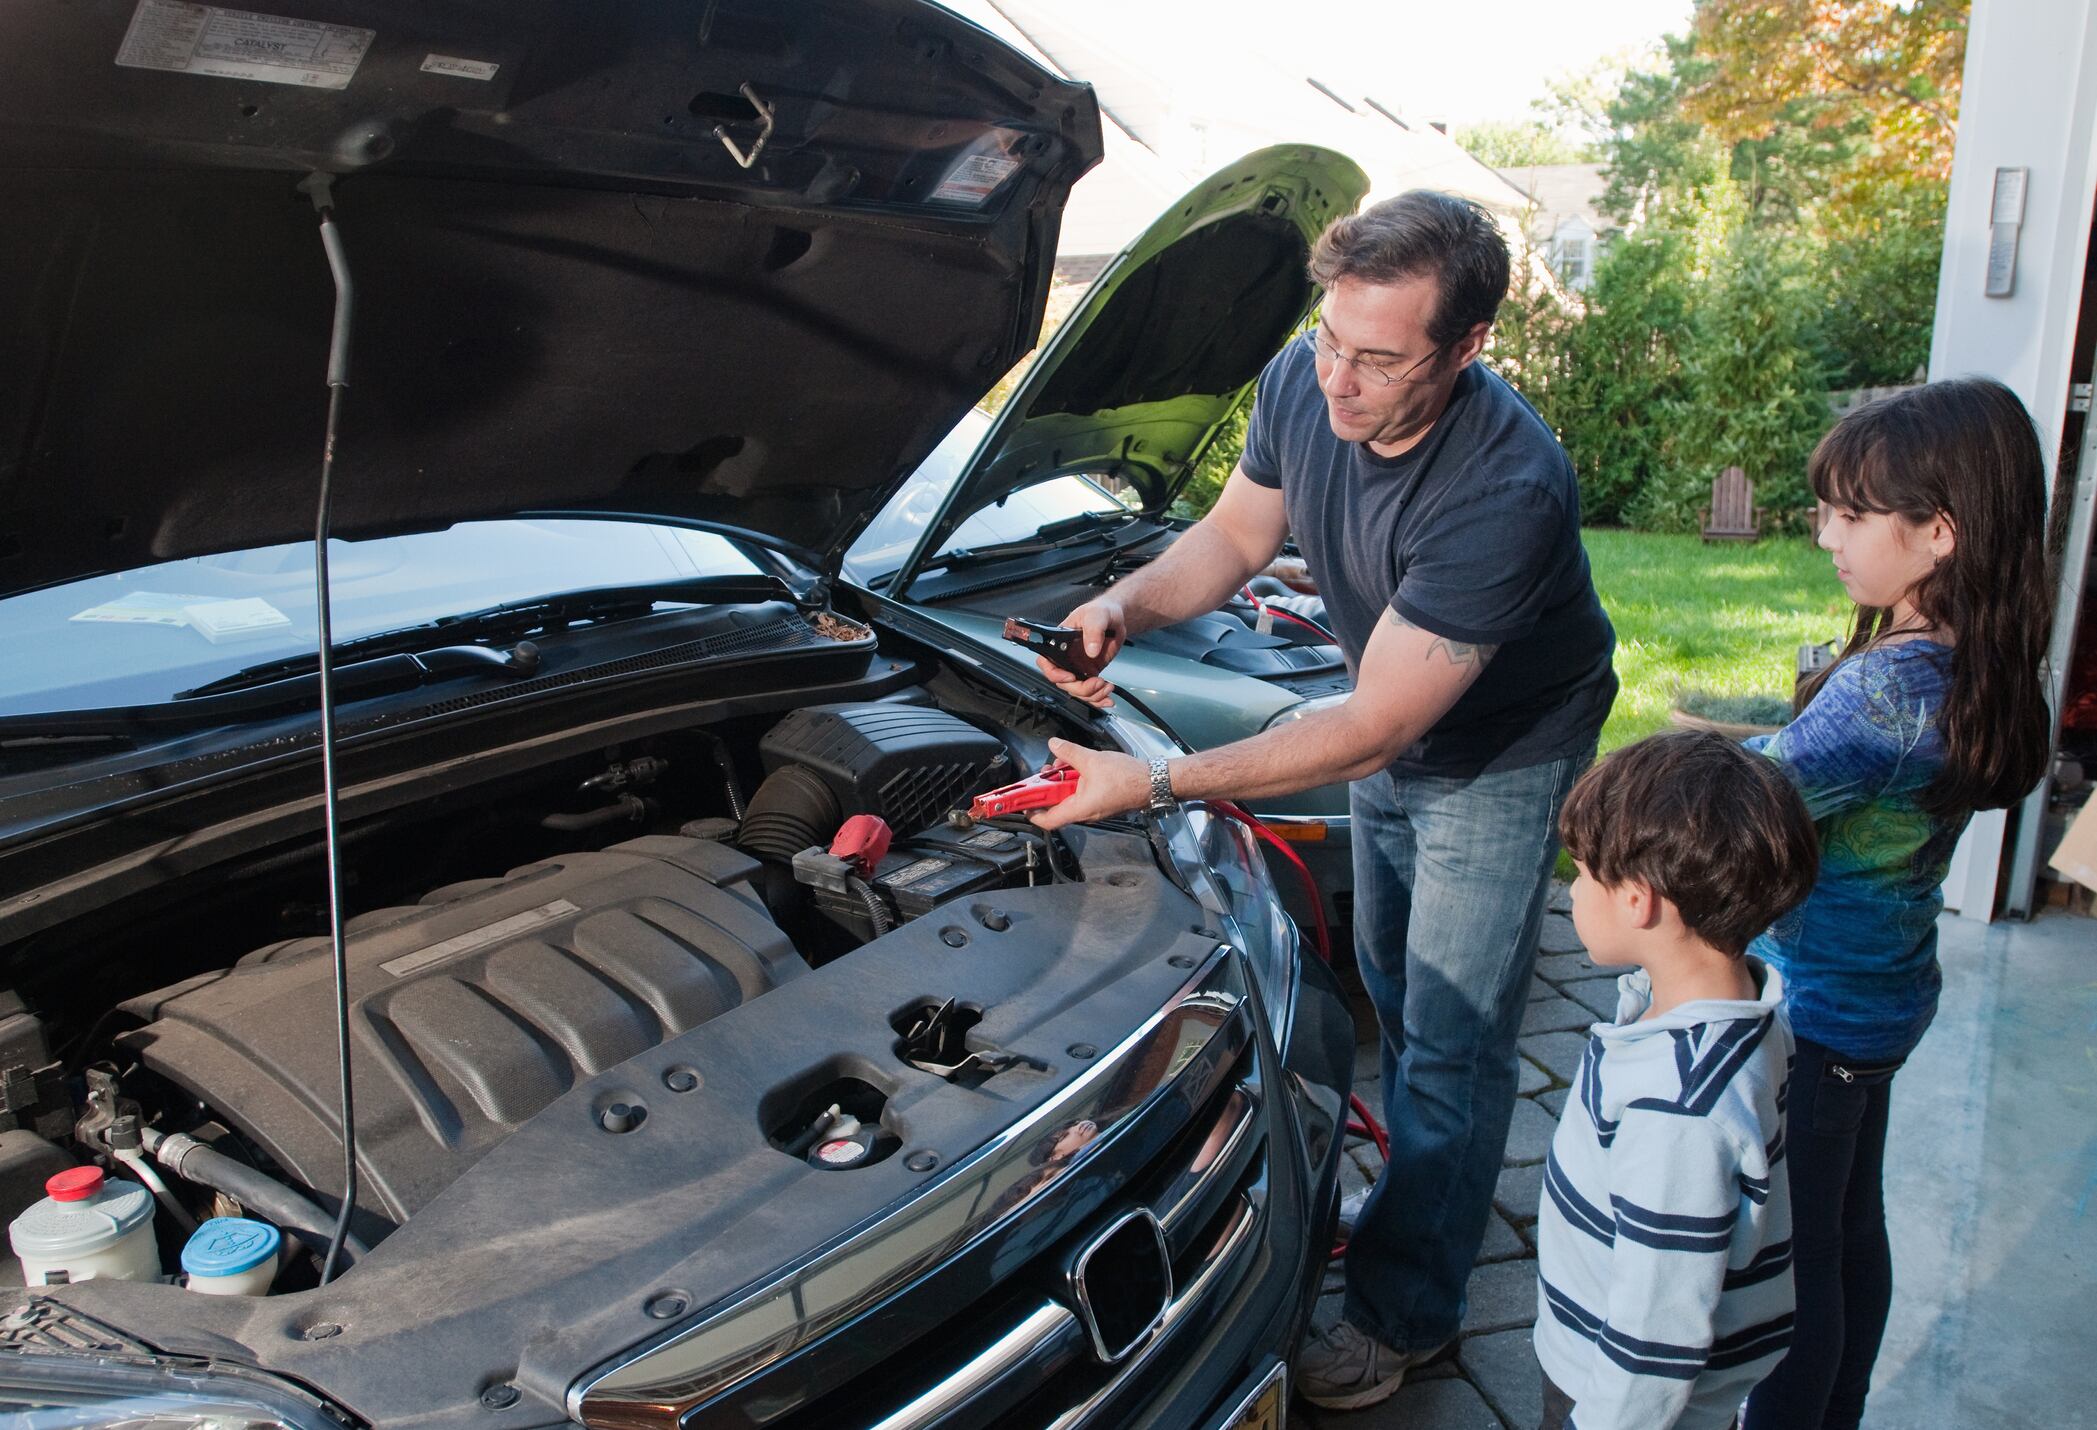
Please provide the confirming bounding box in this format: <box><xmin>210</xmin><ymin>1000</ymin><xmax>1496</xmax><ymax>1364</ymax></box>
<box><xmin>1346</xmin><ymin>755</ymin><xmax>1594</xmax><ymax>1352</ymax></box>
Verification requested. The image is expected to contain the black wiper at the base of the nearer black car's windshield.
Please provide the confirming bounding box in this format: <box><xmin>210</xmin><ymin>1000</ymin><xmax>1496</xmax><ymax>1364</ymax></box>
<box><xmin>174</xmin><ymin>575</ymin><xmax>795</xmax><ymax>700</ymax></box>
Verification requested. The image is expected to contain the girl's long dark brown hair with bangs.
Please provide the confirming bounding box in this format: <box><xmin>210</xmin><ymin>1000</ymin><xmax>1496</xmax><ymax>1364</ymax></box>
<box><xmin>1799</xmin><ymin>377</ymin><xmax>2053</xmax><ymax>814</ymax></box>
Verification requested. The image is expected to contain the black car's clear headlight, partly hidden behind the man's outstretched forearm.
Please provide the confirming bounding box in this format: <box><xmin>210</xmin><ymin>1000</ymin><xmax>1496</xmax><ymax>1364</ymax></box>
<box><xmin>1107</xmin><ymin>696</ymin><xmax>1291</xmax><ymax>1035</ymax></box>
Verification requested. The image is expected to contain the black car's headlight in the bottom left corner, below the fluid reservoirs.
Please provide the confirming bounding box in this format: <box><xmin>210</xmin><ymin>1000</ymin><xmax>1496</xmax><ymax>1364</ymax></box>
<box><xmin>0</xmin><ymin>1355</ymin><xmax>346</xmax><ymax>1430</ymax></box>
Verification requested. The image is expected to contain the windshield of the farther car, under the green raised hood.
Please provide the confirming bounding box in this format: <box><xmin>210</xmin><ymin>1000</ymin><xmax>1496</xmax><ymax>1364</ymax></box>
<box><xmin>845</xmin><ymin>411</ymin><xmax>1130</xmax><ymax>585</ymax></box>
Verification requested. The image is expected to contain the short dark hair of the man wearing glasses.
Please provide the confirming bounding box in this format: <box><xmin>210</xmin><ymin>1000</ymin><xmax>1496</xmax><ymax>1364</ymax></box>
<box><xmin>1311</xmin><ymin>189</ymin><xmax>1508</xmax><ymax>348</ymax></box>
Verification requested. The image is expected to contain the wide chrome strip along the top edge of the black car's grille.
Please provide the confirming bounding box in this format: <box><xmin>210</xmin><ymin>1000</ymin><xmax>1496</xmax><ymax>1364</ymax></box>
<box><xmin>568</xmin><ymin>944</ymin><xmax>1254</xmax><ymax>1424</ymax></box>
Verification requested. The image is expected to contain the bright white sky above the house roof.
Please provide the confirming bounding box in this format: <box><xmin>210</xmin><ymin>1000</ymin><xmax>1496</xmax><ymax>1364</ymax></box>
<box><xmin>1116</xmin><ymin>0</ymin><xmax>1690</xmax><ymax>124</ymax></box>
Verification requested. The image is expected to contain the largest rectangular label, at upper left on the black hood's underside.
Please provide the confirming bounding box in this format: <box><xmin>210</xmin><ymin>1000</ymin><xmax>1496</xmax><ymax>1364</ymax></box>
<box><xmin>117</xmin><ymin>0</ymin><xmax>377</xmax><ymax>90</ymax></box>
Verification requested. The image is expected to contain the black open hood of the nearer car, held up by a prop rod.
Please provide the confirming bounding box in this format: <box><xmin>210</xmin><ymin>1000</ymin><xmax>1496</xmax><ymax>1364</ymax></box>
<box><xmin>0</xmin><ymin>0</ymin><xmax>1101</xmax><ymax>593</ymax></box>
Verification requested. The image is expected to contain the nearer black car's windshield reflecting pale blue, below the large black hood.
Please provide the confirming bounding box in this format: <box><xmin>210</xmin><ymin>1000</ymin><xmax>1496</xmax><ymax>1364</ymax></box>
<box><xmin>0</xmin><ymin>520</ymin><xmax>757</xmax><ymax>715</ymax></box>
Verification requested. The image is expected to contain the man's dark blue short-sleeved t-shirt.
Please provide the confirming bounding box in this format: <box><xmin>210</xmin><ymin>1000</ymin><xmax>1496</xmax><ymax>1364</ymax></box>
<box><xmin>1239</xmin><ymin>342</ymin><xmax>1617</xmax><ymax>778</ymax></box>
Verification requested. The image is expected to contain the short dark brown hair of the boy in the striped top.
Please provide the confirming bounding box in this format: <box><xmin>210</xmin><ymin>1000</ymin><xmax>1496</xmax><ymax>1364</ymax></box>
<box><xmin>1558</xmin><ymin>730</ymin><xmax>1820</xmax><ymax>958</ymax></box>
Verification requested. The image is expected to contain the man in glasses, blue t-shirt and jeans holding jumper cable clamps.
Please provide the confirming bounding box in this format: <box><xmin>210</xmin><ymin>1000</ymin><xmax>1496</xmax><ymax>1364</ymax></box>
<box><xmin>1038</xmin><ymin>191</ymin><xmax>1617</xmax><ymax>1409</ymax></box>
